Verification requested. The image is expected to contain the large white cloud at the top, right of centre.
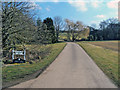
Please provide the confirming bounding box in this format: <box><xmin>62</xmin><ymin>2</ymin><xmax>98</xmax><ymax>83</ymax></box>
<box><xmin>68</xmin><ymin>0</ymin><xmax>88</xmax><ymax>12</ymax></box>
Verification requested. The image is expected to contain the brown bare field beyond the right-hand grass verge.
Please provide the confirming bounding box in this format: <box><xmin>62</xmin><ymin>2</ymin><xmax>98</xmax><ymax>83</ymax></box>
<box><xmin>88</xmin><ymin>41</ymin><xmax>120</xmax><ymax>51</ymax></box>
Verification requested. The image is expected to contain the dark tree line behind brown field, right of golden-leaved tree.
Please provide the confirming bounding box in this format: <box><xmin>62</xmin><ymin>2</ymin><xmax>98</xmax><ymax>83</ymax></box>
<box><xmin>88</xmin><ymin>18</ymin><xmax>120</xmax><ymax>41</ymax></box>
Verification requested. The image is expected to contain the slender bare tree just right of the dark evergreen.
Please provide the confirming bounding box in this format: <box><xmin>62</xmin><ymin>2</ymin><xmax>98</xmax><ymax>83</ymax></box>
<box><xmin>54</xmin><ymin>16</ymin><xmax>64</xmax><ymax>42</ymax></box>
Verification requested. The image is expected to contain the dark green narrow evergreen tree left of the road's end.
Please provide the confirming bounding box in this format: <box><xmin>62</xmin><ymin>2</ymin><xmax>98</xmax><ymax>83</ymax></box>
<box><xmin>43</xmin><ymin>17</ymin><xmax>56</xmax><ymax>43</ymax></box>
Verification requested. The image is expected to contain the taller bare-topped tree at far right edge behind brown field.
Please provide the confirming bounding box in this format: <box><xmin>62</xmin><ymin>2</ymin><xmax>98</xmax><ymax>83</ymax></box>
<box><xmin>100</xmin><ymin>18</ymin><xmax>119</xmax><ymax>40</ymax></box>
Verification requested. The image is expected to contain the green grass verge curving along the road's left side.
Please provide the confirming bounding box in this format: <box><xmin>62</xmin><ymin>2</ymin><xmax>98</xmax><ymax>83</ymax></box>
<box><xmin>2</xmin><ymin>43</ymin><xmax>66</xmax><ymax>82</ymax></box>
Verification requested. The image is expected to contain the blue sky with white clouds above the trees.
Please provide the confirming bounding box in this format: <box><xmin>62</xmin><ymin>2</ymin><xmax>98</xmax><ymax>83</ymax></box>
<box><xmin>32</xmin><ymin>0</ymin><xmax>119</xmax><ymax>27</ymax></box>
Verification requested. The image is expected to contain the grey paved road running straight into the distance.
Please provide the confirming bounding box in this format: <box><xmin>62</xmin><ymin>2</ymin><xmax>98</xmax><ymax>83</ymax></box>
<box><xmin>12</xmin><ymin>43</ymin><xmax>116</xmax><ymax>88</ymax></box>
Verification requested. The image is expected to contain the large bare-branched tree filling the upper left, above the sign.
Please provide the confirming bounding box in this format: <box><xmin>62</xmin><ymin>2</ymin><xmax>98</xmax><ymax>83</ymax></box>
<box><xmin>2</xmin><ymin>2</ymin><xmax>35</xmax><ymax>48</ymax></box>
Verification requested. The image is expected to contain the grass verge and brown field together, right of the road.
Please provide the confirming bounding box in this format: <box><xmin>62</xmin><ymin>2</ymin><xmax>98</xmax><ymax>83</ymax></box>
<box><xmin>78</xmin><ymin>41</ymin><xmax>120</xmax><ymax>86</ymax></box>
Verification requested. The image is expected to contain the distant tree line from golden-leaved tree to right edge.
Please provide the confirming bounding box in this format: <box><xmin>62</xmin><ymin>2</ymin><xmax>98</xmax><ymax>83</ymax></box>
<box><xmin>60</xmin><ymin>18</ymin><xmax>120</xmax><ymax>41</ymax></box>
